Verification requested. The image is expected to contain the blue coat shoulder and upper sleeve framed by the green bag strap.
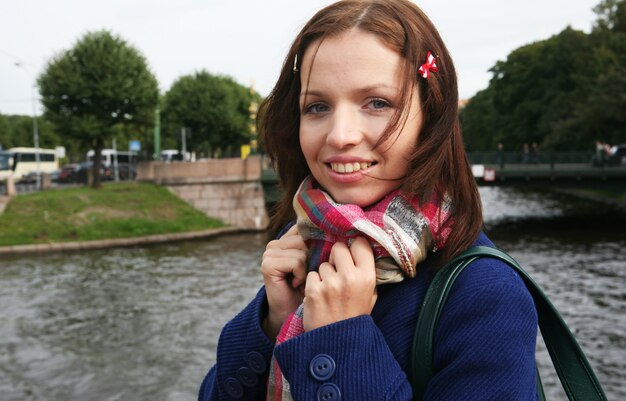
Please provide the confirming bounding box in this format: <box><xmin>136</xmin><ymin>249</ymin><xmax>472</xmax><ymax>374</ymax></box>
<box><xmin>424</xmin><ymin>258</ymin><xmax>537</xmax><ymax>401</ymax></box>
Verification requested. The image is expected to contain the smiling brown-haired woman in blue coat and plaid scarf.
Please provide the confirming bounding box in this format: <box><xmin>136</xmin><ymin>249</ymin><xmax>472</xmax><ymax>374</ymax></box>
<box><xmin>199</xmin><ymin>0</ymin><xmax>537</xmax><ymax>400</ymax></box>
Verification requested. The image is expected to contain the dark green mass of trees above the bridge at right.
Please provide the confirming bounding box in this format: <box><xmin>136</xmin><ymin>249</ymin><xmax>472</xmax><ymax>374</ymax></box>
<box><xmin>461</xmin><ymin>0</ymin><xmax>626</xmax><ymax>150</ymax></box>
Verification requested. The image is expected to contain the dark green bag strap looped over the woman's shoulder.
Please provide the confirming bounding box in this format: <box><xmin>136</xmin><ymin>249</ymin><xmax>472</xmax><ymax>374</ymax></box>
<box><xmin>410</xmin><ymin>246</ymin><xmax>607</xmax><ymax>401</ymax></box>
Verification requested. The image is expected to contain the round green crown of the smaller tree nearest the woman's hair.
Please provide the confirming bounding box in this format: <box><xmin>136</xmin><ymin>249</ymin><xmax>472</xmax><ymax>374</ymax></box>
<box><xmin>161</xmin><ymin>71</ymin><xmax>259</xmax><ymax>156</ymax></box>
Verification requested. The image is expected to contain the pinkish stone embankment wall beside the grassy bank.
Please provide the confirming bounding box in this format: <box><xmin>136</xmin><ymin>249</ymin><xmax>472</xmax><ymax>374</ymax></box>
<box><xmin>137</xmin><ymin>156</ymin><xmax>269</xmax><ymax>230</ymax></box>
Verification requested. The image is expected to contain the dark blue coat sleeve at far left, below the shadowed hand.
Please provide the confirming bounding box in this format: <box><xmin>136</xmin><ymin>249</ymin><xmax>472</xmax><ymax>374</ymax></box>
<box><xmin>198</xmin><ymin>288</ymin><xmax>274</xmax><ymax>401</ymax></box>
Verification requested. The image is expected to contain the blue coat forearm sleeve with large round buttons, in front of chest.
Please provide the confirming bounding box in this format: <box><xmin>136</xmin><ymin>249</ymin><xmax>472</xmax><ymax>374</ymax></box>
<box><xmin>274</xmin><ymin>316</ymin><xmax>411</xmax><ymax>400</ymax></box>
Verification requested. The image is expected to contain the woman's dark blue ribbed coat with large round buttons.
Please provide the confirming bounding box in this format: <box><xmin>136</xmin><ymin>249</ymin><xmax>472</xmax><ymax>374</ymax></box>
<box><xmin>199</xmin><ymin>234</ymin><xmax>537</xmax><ymax>401</ymax></box>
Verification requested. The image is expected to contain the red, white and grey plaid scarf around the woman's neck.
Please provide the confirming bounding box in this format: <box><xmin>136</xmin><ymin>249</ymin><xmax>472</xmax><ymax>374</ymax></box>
<box><xmin>267</xmin><ymin>176</ymin><xmax>451</xmax><ymax>401</ymax></box>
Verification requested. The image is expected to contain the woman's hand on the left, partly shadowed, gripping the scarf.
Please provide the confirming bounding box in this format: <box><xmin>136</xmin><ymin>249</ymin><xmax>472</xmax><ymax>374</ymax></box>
<box><xmin>261</xmin><ymin>225</ymin><xmax>307</xmax><ymax>339</ymax></box>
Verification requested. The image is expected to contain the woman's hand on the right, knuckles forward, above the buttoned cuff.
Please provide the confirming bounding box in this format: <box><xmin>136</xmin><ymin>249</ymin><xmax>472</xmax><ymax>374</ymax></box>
<box><xmin>303</xmin><ymin>237</ymin><xmax>377</xmax><ymax>331</ymax></box>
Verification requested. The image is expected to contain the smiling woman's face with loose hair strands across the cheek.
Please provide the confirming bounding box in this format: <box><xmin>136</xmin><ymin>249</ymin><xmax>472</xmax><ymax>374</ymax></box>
<box><xmin>300</xmin><ymin>29</ymin><xmax>422</xmax><ymax>207</ymax></box>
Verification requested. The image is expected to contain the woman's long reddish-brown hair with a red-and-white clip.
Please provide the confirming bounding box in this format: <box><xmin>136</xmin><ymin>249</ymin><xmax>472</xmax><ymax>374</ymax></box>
<box><xmin>257</xmin><ymin>0</ymin><xmax>482</xmax><ymax>261</ymax></box>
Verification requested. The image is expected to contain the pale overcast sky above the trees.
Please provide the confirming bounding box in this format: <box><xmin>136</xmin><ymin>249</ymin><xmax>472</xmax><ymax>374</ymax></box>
<box><xmin>0</xmin><ymin>0</ymin><xmax>600</xmax><ymax>115</ymax></box>
